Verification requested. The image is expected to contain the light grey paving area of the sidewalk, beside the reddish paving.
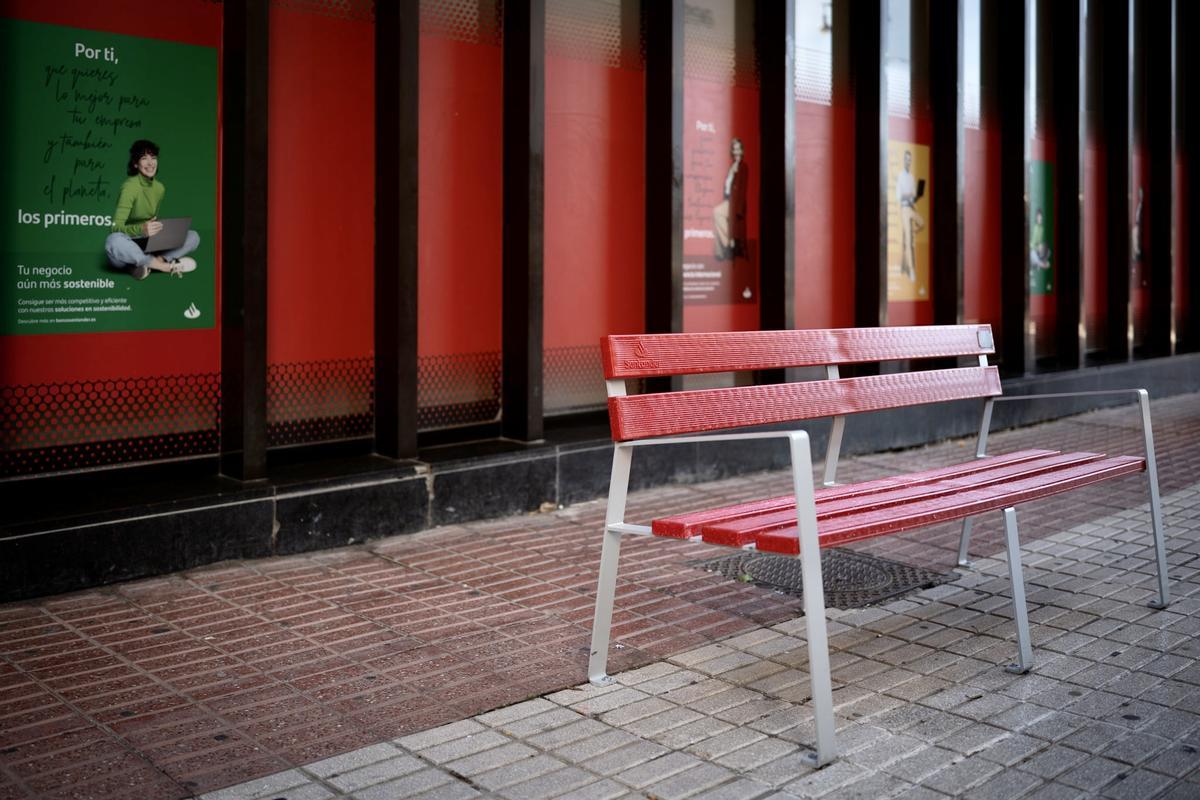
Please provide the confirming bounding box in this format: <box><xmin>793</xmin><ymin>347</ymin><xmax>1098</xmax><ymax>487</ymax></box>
<box><xmin>202</xmin><ymin>485</ymin><xmax>1200</xmax><ymax>800</ymax></box>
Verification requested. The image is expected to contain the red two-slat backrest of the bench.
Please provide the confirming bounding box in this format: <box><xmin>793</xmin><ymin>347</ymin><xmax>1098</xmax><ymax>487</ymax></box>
<box><xmin>600</xmin><ymin>325</ymin><xmax>1001</xmax><ymax>441</ymax></box>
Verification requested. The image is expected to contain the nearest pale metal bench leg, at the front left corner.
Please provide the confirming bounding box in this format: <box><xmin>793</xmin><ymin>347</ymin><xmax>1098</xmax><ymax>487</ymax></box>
<box><xmin>791</xmin><ymin>433</ymin><xmax>838</xmax><ymax>766</ymax></box>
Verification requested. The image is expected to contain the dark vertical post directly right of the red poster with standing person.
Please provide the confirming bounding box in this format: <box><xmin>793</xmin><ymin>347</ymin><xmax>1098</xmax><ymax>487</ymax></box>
<box><xmin>755</xmin><ymin>0</ymin><xmax>796</xmax><ymax>383</ymax></box>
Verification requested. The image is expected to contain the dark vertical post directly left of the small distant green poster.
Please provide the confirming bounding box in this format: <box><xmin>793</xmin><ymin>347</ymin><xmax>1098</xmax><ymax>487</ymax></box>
<box><xmin>998</xmin><ymin>0</ymin><xmax>1034</xmax><ymax>375</ymax></box>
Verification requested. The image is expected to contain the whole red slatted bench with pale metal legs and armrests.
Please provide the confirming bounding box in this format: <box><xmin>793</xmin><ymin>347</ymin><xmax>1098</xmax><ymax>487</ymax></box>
<box><xmin>588</xmin><ymin>325</ymin><xmax>1169</xmax><ymax>765</ymax></box>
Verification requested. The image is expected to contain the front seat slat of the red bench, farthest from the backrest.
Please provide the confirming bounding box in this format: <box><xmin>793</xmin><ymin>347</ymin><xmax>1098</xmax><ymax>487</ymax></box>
<box><xmin>755</xmin><ymin>456</ymin><xmax>1146</xmax><ymax>555</ymax></box>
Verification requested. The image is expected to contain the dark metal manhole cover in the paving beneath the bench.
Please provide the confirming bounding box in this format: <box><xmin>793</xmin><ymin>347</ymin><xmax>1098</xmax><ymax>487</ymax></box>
<box><xmin>690</xmin><ymin>548</ymin><xmax>956</xmax><ymax>609</ymax></box>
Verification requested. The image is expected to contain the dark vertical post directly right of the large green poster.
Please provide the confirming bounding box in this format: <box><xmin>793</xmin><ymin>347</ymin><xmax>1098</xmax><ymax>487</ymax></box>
<box><xmin>221</xmin><ymin>0</ymin><xmax>269</xmax><ymax>481</ymax></box>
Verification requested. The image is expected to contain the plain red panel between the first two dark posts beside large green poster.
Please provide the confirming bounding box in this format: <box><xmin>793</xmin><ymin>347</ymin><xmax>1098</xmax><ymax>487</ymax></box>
<box><xmin>266</xmin><ymin>7</ymin><xmax>374</xmax><ymax>363</ymax></box>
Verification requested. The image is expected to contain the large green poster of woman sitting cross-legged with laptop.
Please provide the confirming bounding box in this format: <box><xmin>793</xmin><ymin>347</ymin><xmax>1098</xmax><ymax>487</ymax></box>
<box><xmin>0</xmin><ymin>19</ymin><xmax>217</xmax><ymax>336</ymax></box>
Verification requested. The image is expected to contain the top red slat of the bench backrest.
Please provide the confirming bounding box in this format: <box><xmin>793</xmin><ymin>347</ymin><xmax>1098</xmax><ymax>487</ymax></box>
<box><xmin>600</xmin><ymin>325</ymin><xmax>995</xmax><ymax>380</ymax></box>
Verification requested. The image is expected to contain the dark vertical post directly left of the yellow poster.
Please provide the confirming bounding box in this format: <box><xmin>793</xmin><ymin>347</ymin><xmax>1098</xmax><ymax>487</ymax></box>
<box><xmin>849</xmin><ymin>0</ymin><xmax>888</xmax><ymax>327</ymax></box>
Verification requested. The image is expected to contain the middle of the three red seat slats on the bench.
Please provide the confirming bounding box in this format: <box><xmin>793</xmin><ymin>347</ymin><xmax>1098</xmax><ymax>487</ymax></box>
<box><xmin>701</xmin><ymin>452</ymin><xmax>1104</xmax><ymax>547</ymax></box>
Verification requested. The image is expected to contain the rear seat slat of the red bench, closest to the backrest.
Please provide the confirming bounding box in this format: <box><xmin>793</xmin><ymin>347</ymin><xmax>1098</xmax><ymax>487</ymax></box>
<box><xmin>652</xmin><ymin>450</ymin><xmax>1057</xmax><ymax>539</ymax></box>
